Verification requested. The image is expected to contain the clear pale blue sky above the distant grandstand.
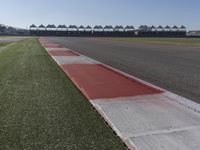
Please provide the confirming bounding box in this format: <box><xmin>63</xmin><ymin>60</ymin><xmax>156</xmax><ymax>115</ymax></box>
<box><xmin>0</xmin><ymin>0</ymin><xmax>200</xmax><ymax>29</ymax></box>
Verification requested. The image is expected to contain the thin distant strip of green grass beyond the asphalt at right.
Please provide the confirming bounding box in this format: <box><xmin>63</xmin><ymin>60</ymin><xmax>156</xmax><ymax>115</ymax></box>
<box><xmin>104</xmin><ymin>38</ymin><xmax>200</xmax><ymax>46</ymax></box>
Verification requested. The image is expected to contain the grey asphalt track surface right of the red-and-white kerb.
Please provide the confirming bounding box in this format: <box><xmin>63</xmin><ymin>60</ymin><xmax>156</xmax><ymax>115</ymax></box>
<box><xmin>47</xmin><ymin>37</ymin><xmax>200</xmax><ymax>103</ymax></box>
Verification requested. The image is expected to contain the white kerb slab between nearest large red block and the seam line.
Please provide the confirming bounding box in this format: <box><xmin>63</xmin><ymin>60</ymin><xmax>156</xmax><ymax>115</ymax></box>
<box><xmin>91</xmin><ymin>94</ymin><xmax>200</xmax><ymax>149</ymax></box>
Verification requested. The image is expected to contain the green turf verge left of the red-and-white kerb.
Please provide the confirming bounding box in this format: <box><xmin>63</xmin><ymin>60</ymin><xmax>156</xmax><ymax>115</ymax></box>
<box><xmin>0</xmin><ymin>38</ymin><xmax>125</xmax><ymax>150</ymax></box>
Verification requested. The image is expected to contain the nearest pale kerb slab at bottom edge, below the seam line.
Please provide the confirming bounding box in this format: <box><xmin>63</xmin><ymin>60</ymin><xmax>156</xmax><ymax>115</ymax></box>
<box><xmin>130</xmin><ymin>129</ymin><xmax>200</xmax><ymax>150</ymax></box>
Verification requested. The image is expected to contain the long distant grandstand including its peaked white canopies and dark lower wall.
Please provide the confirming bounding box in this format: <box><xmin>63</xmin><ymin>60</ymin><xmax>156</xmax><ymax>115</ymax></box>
<box><xmin>29</xmin><ymin>24</ymin><xmax>187</xmax><ymax>37</ymax></box>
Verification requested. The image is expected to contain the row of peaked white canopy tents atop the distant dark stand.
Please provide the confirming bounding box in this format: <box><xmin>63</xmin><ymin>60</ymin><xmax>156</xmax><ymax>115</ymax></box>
<box><xmin>29</xmin><ymin>24</ymin><xmax>186</xmax><ymax>32</ymax></box>
